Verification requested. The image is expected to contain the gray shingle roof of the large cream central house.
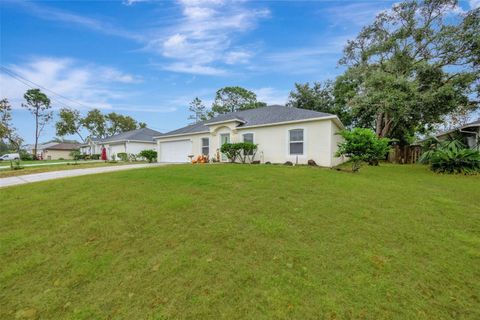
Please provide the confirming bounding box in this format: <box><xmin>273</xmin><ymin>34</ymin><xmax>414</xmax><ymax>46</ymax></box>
<box><xmin>161</xmin><ymin>105</ymin><xmax>332</xmax><ymax>136</ymax></box>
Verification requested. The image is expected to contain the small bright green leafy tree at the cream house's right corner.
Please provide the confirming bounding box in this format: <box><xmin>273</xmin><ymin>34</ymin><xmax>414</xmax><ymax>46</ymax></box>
<box><xmin>336</xmin><ymin>128</ymin><xmax>390</xmax><ymax>172</ymax></box>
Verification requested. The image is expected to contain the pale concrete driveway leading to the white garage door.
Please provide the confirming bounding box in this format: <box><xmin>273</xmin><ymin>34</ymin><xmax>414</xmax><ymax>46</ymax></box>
<box><xmin>0</xmin><ymin>163</ymin><xmax>166</xmax><ymax>188</ymax></box>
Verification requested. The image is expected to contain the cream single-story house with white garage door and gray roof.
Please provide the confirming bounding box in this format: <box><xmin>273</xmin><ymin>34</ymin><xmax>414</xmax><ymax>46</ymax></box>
<box><xmin>156</xmin><ymin>106</ymin><xmax>343</xmax><ymax>167</ymax></box>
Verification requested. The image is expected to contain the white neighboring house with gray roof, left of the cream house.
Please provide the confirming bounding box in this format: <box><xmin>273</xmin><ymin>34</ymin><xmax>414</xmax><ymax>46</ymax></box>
<box><xmin>80</xmin><ymin>128</ymin><xmax>162</xmax><ymax>160</ymax></box>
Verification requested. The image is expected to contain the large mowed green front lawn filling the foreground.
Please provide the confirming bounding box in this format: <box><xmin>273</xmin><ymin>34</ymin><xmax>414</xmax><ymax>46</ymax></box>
<box><xmin>0</xmin><ymin>165</ymin><xmax>480</xmax><ymax>319</ymax></box>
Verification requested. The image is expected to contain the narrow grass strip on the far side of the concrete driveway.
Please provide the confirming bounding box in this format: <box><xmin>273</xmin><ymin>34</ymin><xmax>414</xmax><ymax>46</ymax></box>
<box><xmin>0</xmin><ymin>161</ymin><xmax>137</xmax><ymax>178</ymax></box>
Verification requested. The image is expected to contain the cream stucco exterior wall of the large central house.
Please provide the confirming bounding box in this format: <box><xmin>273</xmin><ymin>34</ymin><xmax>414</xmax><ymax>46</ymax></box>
<box><xmin>157</xmin><ymin>119</ymin><xmax>342</xmax><ymax>167</ymax></box>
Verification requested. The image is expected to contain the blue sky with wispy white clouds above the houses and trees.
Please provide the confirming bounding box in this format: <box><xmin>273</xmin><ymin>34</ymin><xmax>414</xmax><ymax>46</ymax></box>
<box><xmin>0</xmin><ymin>0</ymin><xmax>480</xmax><ymax>142</ymax></box>
